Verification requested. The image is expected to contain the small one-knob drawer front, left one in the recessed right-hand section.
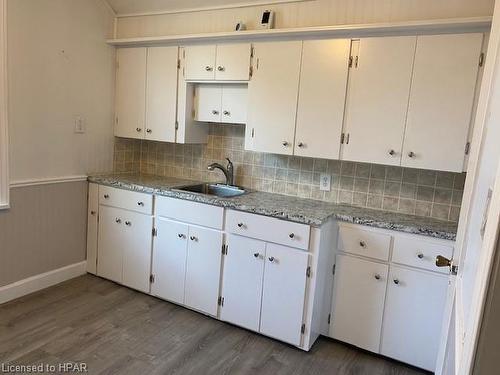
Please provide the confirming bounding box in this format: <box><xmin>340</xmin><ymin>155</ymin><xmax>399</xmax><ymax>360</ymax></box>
<box><xmin>338</xmin><ymin>226</ymin><xmax>391</xmax><ymax>261</ymax></box>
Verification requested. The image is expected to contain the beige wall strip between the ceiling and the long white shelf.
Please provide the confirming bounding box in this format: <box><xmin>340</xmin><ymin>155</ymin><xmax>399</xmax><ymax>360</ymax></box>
<box><xmin>117</xmin><ymin>0</ymin><xmax>494</xmax><ymax>38</ymax></box>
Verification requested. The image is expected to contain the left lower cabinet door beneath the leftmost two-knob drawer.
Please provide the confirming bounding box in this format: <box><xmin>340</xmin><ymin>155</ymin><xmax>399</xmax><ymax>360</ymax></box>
<box><xmin>97</xmin><ymin>206</ymin><xmax>127</xmax><ymax>283</ymax></box>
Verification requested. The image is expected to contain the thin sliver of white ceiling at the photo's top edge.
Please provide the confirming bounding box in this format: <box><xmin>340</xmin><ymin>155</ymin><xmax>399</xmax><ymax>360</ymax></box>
<box><xmin>106</xmin><ymin>0</ymin><xmax>310</xmax><ymax>16</ymax></box>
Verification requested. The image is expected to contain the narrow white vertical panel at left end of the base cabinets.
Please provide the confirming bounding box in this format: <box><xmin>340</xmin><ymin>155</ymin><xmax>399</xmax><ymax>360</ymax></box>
<box><xmin>87</xmin><ymin>184</ymin><xmax>99</xmax><ymax>275</ymax></box>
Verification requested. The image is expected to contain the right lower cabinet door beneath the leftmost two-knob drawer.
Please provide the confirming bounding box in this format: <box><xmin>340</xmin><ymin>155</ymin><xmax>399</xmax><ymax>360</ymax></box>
<box><xmin>122</xmin><ymin>211</ymin><xmax>153</xmax><ymax>293</ymax></box>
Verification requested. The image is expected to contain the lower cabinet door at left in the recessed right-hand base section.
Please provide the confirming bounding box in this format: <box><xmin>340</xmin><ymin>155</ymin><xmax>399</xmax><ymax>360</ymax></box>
<box><xmin>330</xmin><ymin>255</ymin><xmax>389</xmax><ymax>353</ymax></box>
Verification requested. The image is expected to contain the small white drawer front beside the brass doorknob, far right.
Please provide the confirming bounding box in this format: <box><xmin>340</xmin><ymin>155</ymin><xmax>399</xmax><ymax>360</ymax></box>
<box><xmin>392</xmin><ymin>235</ymin><xmax>453</xmax><ymax>273</ymax></box>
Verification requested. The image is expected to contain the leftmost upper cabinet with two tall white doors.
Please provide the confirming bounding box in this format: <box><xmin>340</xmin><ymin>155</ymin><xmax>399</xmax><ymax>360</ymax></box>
<box><xmin>115</xmin><ymin>47</ymin><xmax>178</xmax><ymax>142</ymax></box>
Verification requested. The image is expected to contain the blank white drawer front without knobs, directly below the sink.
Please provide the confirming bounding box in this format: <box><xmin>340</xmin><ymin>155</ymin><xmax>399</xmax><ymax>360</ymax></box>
<box><xmin>155</xmin><ymin>197</ymin><xmax>224</xmax><ymax>230</ymax></box>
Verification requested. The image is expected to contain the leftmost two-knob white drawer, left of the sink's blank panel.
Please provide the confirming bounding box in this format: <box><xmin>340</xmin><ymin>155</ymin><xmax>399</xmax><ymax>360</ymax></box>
<box><xmin>99</xmin><ymin>185</ymin><xmax>153</xmax><ymax>215</ymax></box>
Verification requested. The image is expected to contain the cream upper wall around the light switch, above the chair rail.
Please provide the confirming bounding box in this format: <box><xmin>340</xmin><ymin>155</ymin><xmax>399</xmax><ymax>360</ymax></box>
<box><xmin>7</xmin><ymin>0</ymin><xmax>114</xmax><ymax>183</ymax></box>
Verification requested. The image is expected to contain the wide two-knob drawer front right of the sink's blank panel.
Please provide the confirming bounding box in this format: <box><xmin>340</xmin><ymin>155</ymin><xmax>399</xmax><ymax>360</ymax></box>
<box><xmin>226</xmin><ymin>210</ymin><xmax>311</xmax><ymax>250</ymax></box>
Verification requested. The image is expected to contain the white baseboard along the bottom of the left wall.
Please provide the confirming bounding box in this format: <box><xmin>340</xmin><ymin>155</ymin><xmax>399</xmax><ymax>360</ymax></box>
<box><xmin>0</xmin><ymin>261</ymin><xmax>87</xmax><ymax>304</ymax></box>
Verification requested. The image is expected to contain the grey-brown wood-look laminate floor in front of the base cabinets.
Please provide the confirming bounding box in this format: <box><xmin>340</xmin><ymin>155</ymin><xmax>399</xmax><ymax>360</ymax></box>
<box><xmin>0</xmin><ymin>275</ymin><xmax>425</xmax><ymax>375</ymax></box>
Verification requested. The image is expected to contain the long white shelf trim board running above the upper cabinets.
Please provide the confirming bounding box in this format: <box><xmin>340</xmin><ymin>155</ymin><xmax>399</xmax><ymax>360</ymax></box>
<box><xmin>106</xmin><ymin>17</ymin><xmax>492</xmax><ymax>47</ymax></box>
